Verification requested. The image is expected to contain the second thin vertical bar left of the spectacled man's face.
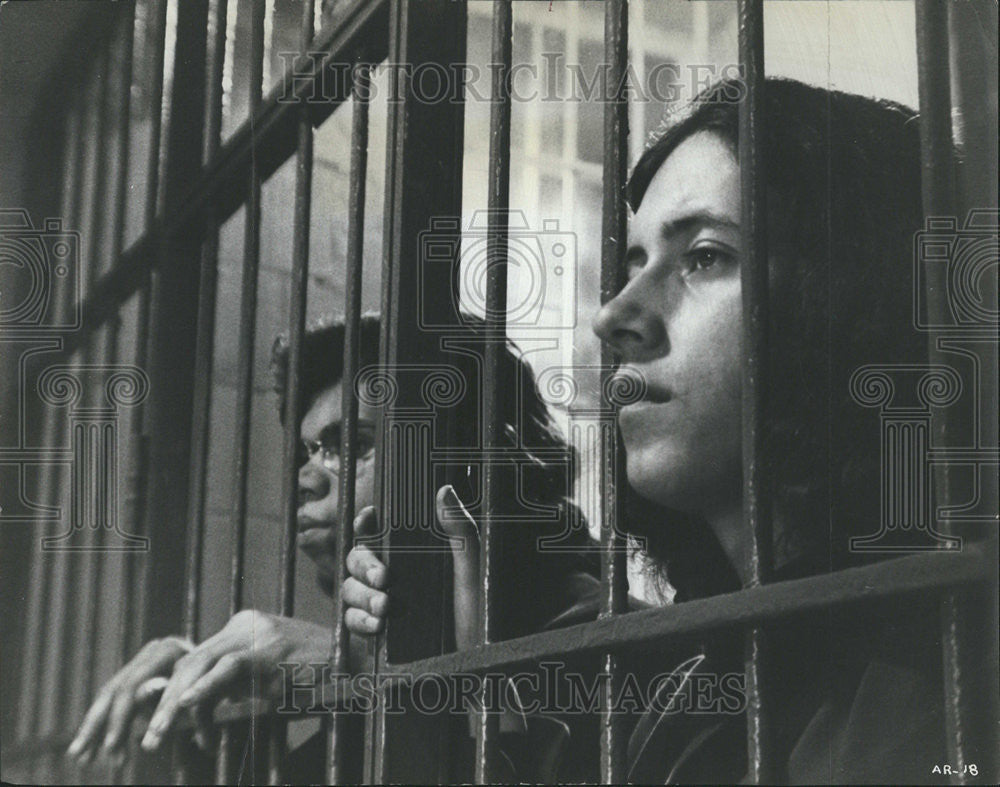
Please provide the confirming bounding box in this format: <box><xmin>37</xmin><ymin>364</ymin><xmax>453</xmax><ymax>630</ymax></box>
<box><xmin>216</xmin><ymin>0</ymin><xmax>266</xmax><ymax>782</ymax></box>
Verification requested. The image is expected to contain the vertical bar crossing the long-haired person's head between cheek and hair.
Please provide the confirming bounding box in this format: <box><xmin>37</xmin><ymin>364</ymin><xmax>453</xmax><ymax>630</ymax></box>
<box><xmin>738</xmin><ymin>0</ymin><xmax>774</xmax><ymax>783</ymax></box>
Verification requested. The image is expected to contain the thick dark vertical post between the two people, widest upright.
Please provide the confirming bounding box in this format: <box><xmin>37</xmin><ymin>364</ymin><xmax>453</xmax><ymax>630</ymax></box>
<box><xmin>365</xmin><ymin>0</ymin><xmax>466</xmax><ymax>782</ymax></box>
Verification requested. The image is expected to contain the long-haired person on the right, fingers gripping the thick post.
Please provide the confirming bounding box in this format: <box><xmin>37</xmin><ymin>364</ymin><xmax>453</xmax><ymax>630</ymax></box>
<box><xmin>347</xmin><ymin>79</ymin><xmax>968</xmax><ymax>783</ymax></box>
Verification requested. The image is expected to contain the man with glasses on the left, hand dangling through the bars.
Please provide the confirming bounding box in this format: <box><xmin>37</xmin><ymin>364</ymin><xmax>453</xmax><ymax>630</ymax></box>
<box><xmin>68</xmin><ymin>315</ymin><xmax>596</xmax><ymax>781</ymax></box>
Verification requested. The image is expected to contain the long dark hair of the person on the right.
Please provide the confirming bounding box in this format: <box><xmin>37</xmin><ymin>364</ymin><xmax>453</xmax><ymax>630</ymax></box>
<box><xmin>628</xmin><ymin>79</ymin><xmax>926</xmax><ymax>596</ymax></box>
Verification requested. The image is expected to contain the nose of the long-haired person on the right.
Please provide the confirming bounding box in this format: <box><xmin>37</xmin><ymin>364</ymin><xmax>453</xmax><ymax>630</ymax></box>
<box><xmin>592</xmin><ymin>280</ymin><xmax>667</xmax><ymax>361</ymax></box>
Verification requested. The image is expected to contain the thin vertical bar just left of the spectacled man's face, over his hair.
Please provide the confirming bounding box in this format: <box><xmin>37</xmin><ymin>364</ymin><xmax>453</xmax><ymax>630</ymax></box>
<box><xmin>268</xmin><ymin>0</ymin><xmax>314</xmax><ymax>784</ymax></box>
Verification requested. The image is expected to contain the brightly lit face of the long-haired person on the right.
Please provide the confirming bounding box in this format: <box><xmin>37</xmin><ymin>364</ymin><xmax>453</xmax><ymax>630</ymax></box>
<box><xmin>594</xmin><ymin>132</ymin><xmax>742</xmax><ymax>515</ymax></box>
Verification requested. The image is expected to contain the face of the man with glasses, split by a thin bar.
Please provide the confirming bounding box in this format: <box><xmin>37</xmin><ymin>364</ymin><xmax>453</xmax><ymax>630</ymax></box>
<box><xmin>298</xmin><ymin>382</ymin><xmax>376</xmax><ymax>593</ymax></box>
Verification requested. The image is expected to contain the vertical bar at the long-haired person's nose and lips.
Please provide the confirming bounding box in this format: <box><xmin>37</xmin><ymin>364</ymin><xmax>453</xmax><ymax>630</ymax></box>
<box><xmin>600</xmin><ymin>0</ymin><xmax>629</xmax><ymax>784</ymax></box>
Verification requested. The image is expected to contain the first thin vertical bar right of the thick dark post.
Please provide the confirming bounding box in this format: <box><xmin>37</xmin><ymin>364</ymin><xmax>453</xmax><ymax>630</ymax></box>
<box><xmin>476</xmin><ymin>0</ymin><xmax>513</xmax><ymax>784</ymax></box>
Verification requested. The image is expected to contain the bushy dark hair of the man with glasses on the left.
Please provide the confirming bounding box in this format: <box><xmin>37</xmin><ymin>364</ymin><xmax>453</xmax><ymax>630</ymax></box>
<box><xmin>271</xmin><ymin>314</ymin><xmax>599</xmax><ymax>637</ymax></box>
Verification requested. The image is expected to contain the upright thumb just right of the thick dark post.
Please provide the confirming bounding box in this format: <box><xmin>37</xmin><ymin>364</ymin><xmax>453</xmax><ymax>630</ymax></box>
<box><xmin>437</xmin><ymin>484</ymin><xmax>480</xmax><ymax>650</ymax></box>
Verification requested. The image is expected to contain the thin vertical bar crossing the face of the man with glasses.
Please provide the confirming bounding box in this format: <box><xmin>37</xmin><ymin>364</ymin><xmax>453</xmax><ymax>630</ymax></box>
<box><xmin>326</xmin><ymin>63</ymin><xmax>371</xmax><ymax>784</ymax></box>
